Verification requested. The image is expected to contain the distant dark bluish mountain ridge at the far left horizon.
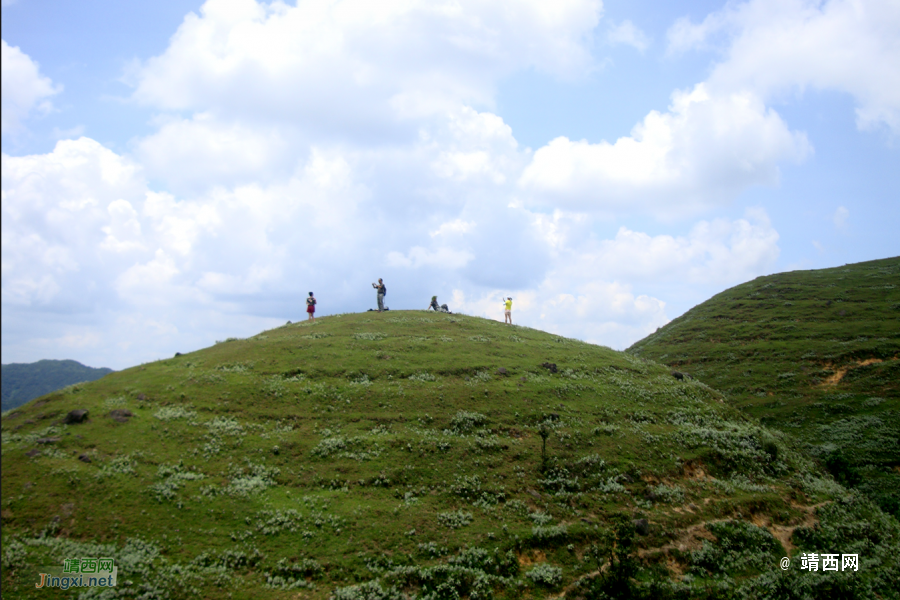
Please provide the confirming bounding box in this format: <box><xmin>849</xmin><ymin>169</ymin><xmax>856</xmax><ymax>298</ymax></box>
<box><xmin>0</xmin><ymin>360</ymin><xmax>113</xmax><ymax>411</ymax></box>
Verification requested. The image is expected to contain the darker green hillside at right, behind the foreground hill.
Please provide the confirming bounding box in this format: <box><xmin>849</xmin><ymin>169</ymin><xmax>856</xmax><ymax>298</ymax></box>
<box><xmin>628</xmin><ymin>258</ymin><xmax>900</xmax><ymax>518</ymax></box>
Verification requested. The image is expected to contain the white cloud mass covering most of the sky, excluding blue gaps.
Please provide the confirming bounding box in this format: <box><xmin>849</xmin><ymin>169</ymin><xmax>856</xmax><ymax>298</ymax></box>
<box><xmin>2</xmin><ymin>0</ymin><xmax>900</xmax><ymax>367</ymax></box>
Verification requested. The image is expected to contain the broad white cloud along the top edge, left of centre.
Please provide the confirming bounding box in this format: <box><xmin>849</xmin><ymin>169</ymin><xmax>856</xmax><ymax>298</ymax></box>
<box><xmin>131</xmin><ymin>0</ymin><xmax>602</xmax><ymax>139</ymax></box>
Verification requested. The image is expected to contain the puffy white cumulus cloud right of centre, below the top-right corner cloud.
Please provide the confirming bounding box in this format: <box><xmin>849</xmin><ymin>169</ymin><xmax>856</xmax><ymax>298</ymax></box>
<box><xmin>519</xmin><ymin>84</ymin><xmax>810</xmax><ymax>216</ymax></box>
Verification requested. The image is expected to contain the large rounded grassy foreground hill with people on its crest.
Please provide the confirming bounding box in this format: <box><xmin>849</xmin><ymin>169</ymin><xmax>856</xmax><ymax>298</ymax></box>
<box><xmin>2</xmin><ymin>311</ymin><xmax>900</xmax><ymax>600</ymax></box>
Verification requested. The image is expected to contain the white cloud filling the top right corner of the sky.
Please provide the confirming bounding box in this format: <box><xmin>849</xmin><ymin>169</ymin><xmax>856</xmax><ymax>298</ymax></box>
<box><xmin>668</xmin><ymin>0</ymin><xmax>900</xmax><ymax>134</ymax></box>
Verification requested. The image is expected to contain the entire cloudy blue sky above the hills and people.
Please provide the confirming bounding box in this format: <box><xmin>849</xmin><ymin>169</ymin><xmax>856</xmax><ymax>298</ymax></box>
<box><xmin>2</xmin><ymin>0</ymin><xmax>900</xmax><ymax>368</ymax></box>
